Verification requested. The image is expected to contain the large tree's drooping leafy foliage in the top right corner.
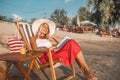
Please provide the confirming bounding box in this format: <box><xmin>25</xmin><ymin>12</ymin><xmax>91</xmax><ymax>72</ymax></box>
<box><xmin>88</xmin><ymin>0</ymin><xmax>120</xmax><ymax>28</ymax></box>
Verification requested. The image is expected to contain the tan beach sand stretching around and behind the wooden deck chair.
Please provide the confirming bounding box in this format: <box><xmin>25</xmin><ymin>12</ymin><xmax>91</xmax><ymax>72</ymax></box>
<box><xmin>0</xmin><ymin>22</ymin><xmax>120</xmax><ymax>80</ymax></box>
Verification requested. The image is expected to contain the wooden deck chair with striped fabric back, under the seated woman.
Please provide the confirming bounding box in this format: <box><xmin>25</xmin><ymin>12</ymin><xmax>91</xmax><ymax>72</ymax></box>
<box><xmin>17</xmin><ymin>22</ymin><xmax>76</xmax><ymax>80</ymax></box>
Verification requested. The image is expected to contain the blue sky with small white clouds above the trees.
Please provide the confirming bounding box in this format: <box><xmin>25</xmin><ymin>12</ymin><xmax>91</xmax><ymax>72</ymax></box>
<box><xmin>0</xmin><ymin>0</ymin><xmax>88</xmax><ymax>21</ymax></box>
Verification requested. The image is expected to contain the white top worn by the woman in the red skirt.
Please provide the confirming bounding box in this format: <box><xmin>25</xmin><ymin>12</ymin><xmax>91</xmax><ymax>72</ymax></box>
<box><xmin>36</xmin><ymin>39</ymin><xmax>52</xmax><ymax>48</ymax></box>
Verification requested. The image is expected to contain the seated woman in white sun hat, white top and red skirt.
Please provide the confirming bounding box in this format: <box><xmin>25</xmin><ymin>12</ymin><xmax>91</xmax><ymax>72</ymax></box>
<box><xmin>32</xmin><ymin>19</ymin><xmax>97</xmax><ymax>80</ymax></box>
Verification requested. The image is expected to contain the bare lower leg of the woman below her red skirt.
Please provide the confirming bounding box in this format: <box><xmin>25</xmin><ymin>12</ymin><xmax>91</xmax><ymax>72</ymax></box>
<box><xmin>76</xmin><ymin>52</ymin><xmax>97</xmax><ymax>80</ymax></box>
